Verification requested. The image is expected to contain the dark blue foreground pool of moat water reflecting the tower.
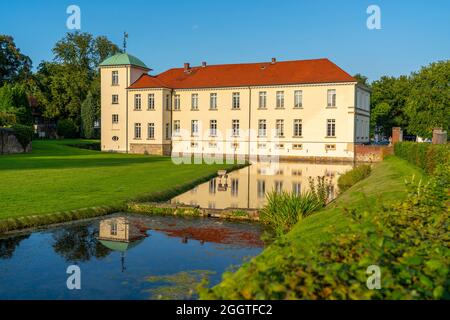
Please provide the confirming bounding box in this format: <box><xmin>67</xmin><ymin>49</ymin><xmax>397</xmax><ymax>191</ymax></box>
<box><xmin>0</xmin><ymin>214</ymin><xmax>264</xmax><ymax>299</ymax></box>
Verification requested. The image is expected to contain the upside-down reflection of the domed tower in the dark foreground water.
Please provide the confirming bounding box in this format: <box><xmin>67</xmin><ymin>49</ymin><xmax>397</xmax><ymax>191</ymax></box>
<box><xmin>98</xmin><ymin>217</ymin><xmax>147</xmax><ymax>272</ymax></box>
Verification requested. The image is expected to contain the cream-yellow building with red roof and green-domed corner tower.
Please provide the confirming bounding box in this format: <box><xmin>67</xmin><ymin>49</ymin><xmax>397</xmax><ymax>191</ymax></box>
<box><xmin>100</xmin><ymin>53</ymin><xmax>370</xmax><ymax>160</ymax></box>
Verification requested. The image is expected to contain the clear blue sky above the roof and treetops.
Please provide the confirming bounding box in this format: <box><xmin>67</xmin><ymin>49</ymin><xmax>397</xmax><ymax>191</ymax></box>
<box><xmin>0</xmin><ymin>0</ymin><xmax>450</xmax><ymax>80</ymax></box>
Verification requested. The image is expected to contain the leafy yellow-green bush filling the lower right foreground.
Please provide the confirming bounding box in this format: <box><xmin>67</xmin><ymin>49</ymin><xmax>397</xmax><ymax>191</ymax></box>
<box><xmin>199</xmin><ymin>166</ymin><xmax>450</xmax><ymax>299</ymax></box>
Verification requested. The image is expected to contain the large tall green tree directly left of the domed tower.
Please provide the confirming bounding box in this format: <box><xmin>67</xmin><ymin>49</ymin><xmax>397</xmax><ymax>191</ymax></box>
<box><xmin>36</xmin><ymin>32</ymin><xmax>120</xmax><ymax>126</ymax></box>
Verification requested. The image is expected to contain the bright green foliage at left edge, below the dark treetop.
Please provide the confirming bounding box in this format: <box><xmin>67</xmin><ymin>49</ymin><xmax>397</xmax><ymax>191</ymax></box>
<box><xmin>0</xmin><ymin>83</ymin><xmax>32</xmax><ymax>126</ymax></box>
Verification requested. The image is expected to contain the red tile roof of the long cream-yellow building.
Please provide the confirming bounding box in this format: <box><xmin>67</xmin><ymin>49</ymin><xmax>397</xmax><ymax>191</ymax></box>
<box><xmin>126</xmin><ymin>59</ymin><xmax>356</xmax><ymax>89</ymax></box>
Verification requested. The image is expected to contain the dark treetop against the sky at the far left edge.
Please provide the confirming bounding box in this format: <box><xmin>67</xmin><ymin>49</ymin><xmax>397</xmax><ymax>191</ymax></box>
<box><xmin>0</xmin><ymin>34</ymin><xmax>32</xmax><ymax>86</ymax></box>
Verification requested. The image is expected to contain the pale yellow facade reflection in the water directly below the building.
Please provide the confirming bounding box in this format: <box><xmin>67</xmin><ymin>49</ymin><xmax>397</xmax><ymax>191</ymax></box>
<box><xmin>172</xmin><ymin>162</ymin><xmax>352</xmax><ymax>209</ymax></box>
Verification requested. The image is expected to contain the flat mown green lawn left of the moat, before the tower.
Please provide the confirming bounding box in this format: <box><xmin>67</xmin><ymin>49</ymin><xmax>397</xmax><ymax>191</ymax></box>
<box><xmin>0</xmin><ymin>140</ymin><xmax>236</xmax><ymax>219</ymax></box>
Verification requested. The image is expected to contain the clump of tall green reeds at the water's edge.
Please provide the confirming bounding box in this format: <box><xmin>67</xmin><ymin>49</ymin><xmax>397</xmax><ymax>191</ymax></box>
<box><xmin>259</xmin><ymin>191</ymin><xmax>324</xmax><ymax>236</ymax></box>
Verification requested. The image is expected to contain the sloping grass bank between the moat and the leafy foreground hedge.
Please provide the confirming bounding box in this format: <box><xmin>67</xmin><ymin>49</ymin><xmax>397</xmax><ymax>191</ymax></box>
<box><xmin>203</xmin><ymin>156</ymin><xmax>427</xmax><ymax>299</ymax></box>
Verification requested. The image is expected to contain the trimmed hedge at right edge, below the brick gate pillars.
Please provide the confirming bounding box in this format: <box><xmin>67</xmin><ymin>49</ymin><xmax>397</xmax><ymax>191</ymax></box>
<box><xmin>394</xmin><ymin>142</ymin><xmax>450</xmax><ymax>174</ymax></box>
